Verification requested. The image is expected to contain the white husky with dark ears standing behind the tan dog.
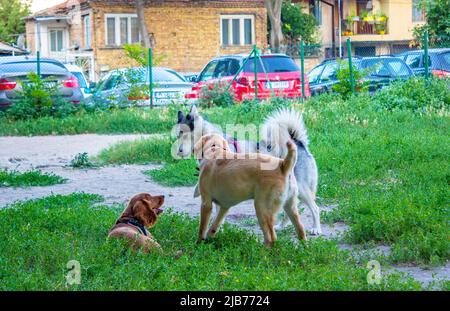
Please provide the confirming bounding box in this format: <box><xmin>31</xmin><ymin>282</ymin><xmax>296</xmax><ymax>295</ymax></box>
<box><xmin>175</xmin><ymin>106</ymin><xmax>322</xmax><ymax>235</ymax></box>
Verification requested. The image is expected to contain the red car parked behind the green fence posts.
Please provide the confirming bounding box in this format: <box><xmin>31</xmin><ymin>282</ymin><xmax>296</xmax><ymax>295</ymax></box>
<box><xmin>185</xmin><ymin>54</ymin><xmax>311</xmax><ymax>101</ymax></box>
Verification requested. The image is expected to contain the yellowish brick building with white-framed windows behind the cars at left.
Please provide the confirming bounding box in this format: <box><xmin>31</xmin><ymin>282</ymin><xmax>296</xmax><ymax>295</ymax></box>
<box><xmin>26</xmin><ymin>0</ymin><xmax>267</xmax><ymax>81</ymax></box>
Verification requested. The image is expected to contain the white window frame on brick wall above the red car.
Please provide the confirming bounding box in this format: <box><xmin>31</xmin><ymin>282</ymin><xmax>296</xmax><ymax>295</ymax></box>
<box><xmin>219</xmin><ymin>14</ymin><xmax>256</xmax><ymax>47</ymax></box>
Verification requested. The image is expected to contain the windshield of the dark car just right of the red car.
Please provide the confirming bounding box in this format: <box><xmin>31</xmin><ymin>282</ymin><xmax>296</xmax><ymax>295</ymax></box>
<box><xmin>361</xmin><ymin>58</ymin><xmax>411</xmax><ymax>78</ymax></box>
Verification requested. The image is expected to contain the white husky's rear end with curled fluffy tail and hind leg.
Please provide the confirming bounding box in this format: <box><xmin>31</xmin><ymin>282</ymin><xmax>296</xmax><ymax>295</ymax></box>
<box><xmin>260</xmin><ymin>108</ymin><xmax>322</xmax><ymax>234</ymax></box>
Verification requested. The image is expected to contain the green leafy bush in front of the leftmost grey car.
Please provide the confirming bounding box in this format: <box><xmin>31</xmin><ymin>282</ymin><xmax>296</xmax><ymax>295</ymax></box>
<box><xmin>6</xmin><ymin>73</ymin><xmax>80</xmax><ymax>120</ymax></box>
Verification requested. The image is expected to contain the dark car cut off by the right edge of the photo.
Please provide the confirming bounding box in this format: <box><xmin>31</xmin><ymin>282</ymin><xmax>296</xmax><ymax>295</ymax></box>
<box><xmin>397</xmin><ymin>48</ymin><xmax>450</xmax><ymax>78</ymax></box>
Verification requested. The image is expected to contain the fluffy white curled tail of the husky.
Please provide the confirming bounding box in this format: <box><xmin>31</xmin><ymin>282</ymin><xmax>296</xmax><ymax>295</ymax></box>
<box><xmin>265</xmin><ymin>108</ymin><xmax>309</xmax><ymax>148</ymax></box>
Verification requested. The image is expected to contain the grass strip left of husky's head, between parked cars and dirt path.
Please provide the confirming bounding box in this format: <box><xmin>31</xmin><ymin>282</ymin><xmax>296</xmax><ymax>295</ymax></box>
<box><xmin>0</xmin><ymin>108</ymin><xmax>176</xmax><ymax>136</ymax></box>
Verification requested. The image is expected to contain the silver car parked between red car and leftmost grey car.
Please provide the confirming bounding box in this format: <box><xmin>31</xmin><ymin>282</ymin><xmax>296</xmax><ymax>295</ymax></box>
<box><xmin>87</xmin><ymin>67</ymin><xmax>192</xmax><ymax>106</ymax></box>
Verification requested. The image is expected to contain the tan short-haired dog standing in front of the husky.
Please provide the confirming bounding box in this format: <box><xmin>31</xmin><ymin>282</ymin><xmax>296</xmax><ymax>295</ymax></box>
<box><xmin>194</xmin><ymin>134</ymin><xmax>306</xmax><ymax>246</ymax></box>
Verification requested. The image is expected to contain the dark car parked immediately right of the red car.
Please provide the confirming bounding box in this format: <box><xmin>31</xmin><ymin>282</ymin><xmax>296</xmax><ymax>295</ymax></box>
<box><xmin>308</xmin><ymin>56</ymin><xmax>414</xmax><ymax>95</ymax></box>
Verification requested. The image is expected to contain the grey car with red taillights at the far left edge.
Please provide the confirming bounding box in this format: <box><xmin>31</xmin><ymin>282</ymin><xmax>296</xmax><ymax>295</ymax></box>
<box><xmin>0</xmin><ymin>56</ymin><xmax>83</xmax><ymax>109</ymax></box>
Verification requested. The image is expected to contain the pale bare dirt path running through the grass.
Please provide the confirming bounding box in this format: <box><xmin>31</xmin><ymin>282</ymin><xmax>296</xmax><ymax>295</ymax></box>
<box><xmin>0</xmin><ymin>134</ymin><xmax>450</xmax><ymax>284</ymax></box>
